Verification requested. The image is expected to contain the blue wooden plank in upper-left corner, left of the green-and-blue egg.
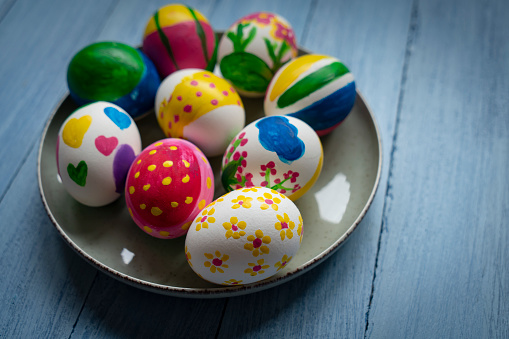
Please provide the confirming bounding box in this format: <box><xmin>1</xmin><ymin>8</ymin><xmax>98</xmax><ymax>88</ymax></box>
<box><xmin>0</xmin><ymin>0</ymin><xmax>114</xmax><ymax>200</ymax></box>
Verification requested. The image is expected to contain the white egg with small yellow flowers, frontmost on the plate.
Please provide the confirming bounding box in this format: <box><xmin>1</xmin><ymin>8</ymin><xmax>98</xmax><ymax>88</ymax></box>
<box><xmin>185</xmin><ymin>187</ymin><xmax>304</xmax><ymax>285</ymax></box>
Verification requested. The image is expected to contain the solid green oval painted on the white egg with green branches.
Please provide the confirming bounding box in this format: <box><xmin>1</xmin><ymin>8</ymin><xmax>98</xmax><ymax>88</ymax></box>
<box><xmin>219</xmin><ymin>52</ymin><xmax>274</xmax><ymax>92</ymax></box>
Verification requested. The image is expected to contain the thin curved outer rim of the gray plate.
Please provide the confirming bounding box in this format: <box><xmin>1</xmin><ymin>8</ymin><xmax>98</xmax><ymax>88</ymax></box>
<box><xmin>37</xmin><ymin>88</ymin><xmax>383</xmax><ymax>298</ymax></box>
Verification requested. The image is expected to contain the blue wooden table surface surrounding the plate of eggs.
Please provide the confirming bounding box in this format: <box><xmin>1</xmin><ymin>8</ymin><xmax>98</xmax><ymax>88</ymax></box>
<box><xmin>0</xmin><ymin>0</ymin><xmax>509</xmax><ymax>338</ymax></box>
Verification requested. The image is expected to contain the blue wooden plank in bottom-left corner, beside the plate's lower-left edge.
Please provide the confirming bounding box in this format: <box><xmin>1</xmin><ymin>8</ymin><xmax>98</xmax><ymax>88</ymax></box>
<box><xmin>0</xmin><ymin>148</ymin><xmax>97</xmax><ymax>338</ymax></box>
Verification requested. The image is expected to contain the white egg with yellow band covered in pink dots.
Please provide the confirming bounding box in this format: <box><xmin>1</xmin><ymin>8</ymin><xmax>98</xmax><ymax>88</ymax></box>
<box><xmin>155</xmin><ymin>69</ymin><xmax>245</xmax><ymax>156</ymax></box>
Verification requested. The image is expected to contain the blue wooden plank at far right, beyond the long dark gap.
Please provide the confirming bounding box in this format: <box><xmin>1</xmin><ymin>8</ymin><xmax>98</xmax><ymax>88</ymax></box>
<box><xmin>367</xmin><ymin>0</ymin><xmax>509</xmax><ymax>338</ymax></box>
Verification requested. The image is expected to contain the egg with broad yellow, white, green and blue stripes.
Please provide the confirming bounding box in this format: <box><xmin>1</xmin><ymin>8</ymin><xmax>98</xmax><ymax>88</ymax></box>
<box><xmin>264</xmin><ymin>54</ymin><xmax>356</xmax><ymax>136</ymax></box>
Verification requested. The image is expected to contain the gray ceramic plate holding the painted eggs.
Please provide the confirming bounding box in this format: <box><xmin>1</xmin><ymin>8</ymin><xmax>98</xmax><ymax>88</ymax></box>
<box><xmin>38</xmin><ymin>78</ymin><xmax>382</xmax><ymax>298</ymax></box>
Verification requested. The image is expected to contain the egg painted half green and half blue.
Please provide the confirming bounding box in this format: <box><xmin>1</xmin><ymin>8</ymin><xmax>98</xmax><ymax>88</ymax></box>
<box><xmin>67</xmin><ymin>42</ymin><xmax>161</xmax><ymax>118</ymax></box>
